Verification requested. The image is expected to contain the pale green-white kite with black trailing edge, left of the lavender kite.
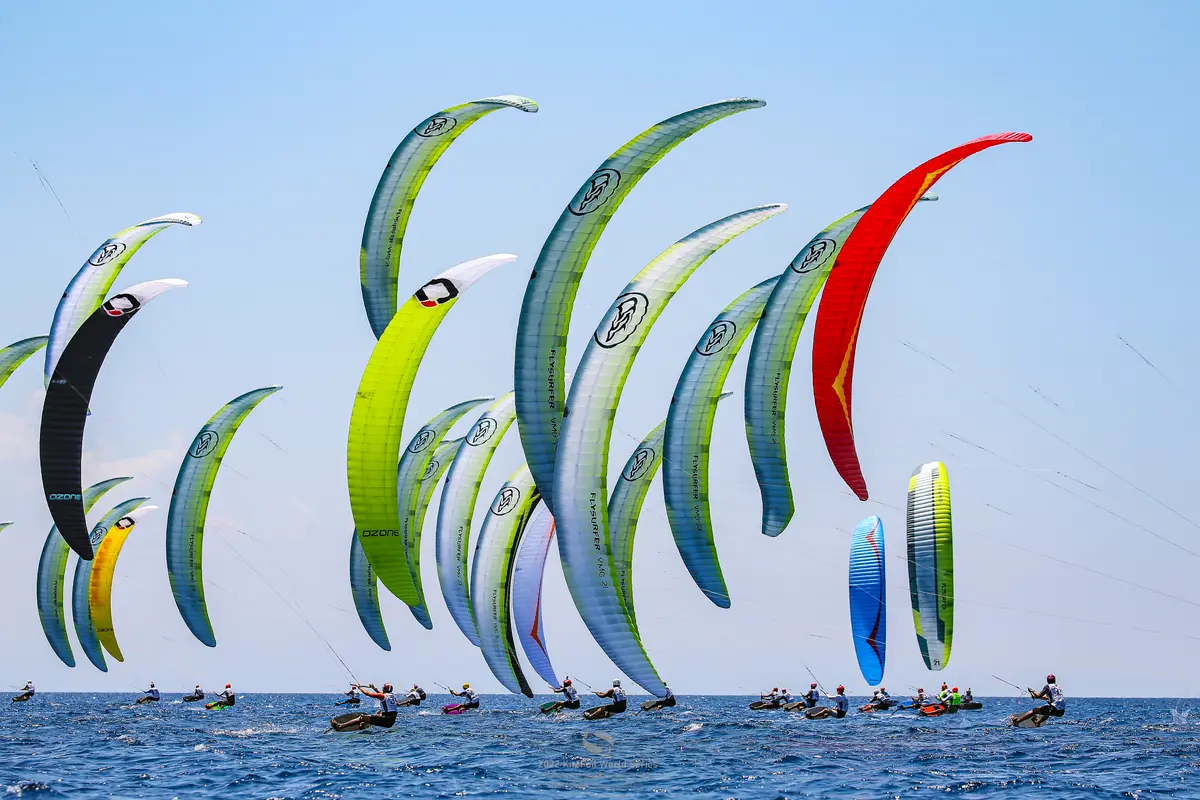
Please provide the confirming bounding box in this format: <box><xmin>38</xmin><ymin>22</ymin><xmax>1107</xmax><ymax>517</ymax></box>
<box><xmin>470</xmin><ymin>464</ymin><xmax>538</xmax><ymax>697</ymax></box>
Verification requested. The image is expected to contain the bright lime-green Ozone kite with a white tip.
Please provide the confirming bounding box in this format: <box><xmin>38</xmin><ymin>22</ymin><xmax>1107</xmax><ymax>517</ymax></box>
<box><xmin>346</xmin><ymin>254</ymin><xmax>516</xmax><ymax>606</ymax></box>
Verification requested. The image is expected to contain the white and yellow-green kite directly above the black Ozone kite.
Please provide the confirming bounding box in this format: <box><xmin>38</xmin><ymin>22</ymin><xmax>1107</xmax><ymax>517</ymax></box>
<box><xmin>46</xmin><ymin>212</ymin><xmax>200</xmax><ymax>386</ymax></box>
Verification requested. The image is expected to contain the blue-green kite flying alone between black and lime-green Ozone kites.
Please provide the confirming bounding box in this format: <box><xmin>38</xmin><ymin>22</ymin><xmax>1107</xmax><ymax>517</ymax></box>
<box><xmin>167</xmin><ymin>386</ymin><xmax>282</xmax><ymax>648</ymax></box>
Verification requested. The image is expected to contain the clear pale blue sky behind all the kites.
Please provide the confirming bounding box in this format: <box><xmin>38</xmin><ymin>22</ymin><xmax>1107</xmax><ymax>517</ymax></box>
<box><xmin>0</xmin><ymin>1</ymin><xmax>1200</xmax><ymax>697</ymax></box>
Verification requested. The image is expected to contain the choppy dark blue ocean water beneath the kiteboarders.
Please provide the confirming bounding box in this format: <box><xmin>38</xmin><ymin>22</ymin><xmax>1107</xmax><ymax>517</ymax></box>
<box><xmin>0</xmin><ymin>693</ymin><xmax>1200</xmax><ymax>800</ymax></box>
